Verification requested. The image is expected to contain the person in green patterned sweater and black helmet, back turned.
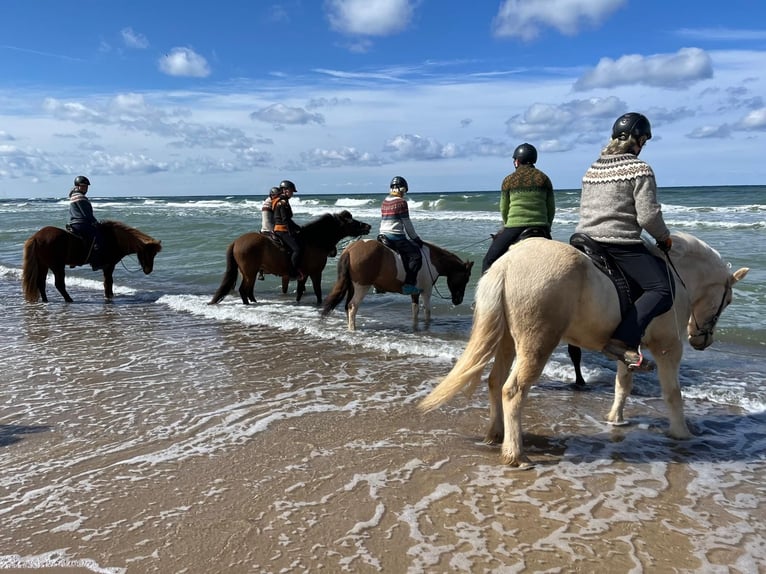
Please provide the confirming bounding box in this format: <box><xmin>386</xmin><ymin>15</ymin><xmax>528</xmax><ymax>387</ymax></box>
<box><xmin>481</xmin><ymin>143</ymin><xmax>556</xmax><ymax>274</ymax></box>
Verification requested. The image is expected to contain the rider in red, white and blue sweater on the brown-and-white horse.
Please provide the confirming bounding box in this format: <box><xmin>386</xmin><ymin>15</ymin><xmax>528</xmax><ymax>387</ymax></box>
<box><xmin>380</xmin><ymin>175</ymin><xmax>423</xmax><ymax>295</ymax></box>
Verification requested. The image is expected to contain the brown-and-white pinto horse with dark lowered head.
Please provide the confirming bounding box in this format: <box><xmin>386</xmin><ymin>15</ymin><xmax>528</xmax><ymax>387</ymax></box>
<box><xmin>322</xmin><ymin>239</ymin><xmax>473</xmax><ymax>331</ymax></box>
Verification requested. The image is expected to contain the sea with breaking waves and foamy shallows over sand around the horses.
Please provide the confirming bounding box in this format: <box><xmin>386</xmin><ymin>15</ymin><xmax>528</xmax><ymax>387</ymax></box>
<box><xmin>0</xmin><ymin>186</ymin><xmax>766</xmax><ymax>573</ymax></box>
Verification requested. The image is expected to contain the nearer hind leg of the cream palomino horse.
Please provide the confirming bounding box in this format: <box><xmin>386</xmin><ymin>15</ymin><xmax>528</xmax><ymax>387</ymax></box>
<box><xmin>502</xmin><ymin>342</ymin><xmax>555</xmax><ymax>468</ymax></box>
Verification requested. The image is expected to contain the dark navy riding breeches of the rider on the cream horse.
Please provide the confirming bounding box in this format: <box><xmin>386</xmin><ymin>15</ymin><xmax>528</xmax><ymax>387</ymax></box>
<box><xmin>602</xmin><ymin>243</ymin><xmax>675</xmax><ymax>349</ymax></box>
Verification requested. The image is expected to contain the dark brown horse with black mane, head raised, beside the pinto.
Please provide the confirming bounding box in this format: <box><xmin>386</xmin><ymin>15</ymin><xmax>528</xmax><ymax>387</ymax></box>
<box><xmin>208</xmin><ymin>210</ymin><xmax>372</xmax><ymax>305</ymax></box>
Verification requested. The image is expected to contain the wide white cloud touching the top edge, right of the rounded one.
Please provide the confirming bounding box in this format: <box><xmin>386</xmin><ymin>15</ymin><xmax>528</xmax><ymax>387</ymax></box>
<box><xmin>492</xmin><ymin>0</ymin><xmax>627</xmax><ymax>40</ymax></box>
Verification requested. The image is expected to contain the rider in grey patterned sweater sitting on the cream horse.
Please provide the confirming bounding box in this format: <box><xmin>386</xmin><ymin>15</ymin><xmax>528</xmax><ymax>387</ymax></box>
<box><xmin>576</xmin><ymin>112</ymin><xmax>673</xmax><ymax>370</ymax></box>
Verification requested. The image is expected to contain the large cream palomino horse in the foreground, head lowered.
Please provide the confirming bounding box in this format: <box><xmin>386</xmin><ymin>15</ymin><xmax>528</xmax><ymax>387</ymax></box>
<box><xmin>420</xmin><ymin>233</ymin><xmax>749</xmax><ymax>467</ymax></box>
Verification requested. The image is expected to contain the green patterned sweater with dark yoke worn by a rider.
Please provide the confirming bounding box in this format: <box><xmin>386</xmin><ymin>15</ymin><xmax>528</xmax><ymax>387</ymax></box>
<box><xmin>500</xmin><ymin>164</ymin><xmax>556</xmax><ymax>228</ymax></box>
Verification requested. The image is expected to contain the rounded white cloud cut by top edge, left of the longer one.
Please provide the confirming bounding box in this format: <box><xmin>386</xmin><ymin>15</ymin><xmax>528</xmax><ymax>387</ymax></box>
<box><xmin>325</xmin><ymin>0</ymin><xmax>417</xmax><ymax>36</ymax></box>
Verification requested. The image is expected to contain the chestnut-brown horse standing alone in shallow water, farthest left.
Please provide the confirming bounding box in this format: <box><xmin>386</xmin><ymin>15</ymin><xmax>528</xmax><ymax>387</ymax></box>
<box><xmin>21</xmin><ymin>221</ymin><xmax>162</xmax><ymax>303</ymax></box>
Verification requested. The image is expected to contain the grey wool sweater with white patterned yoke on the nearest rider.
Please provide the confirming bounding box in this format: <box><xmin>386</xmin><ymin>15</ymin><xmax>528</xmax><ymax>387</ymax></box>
<box><xmin>576</xmin><ymin>153</ymin><xmax>670</xmax><ymax>245</ymax></box>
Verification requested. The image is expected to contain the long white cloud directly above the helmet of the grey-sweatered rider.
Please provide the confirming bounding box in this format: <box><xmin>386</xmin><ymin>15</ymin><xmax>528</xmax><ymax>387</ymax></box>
<box><xmin>574</xmin><ymin>48</ymin><xmax>713</xmax><ymax>91</ymax></box>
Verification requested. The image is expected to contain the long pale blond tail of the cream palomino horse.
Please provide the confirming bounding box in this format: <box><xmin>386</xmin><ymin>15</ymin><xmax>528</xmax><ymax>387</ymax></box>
<box><xmin>418</xmin><ymin>272</ymin><xmax>508</xmax><ymax>412</ymax></box>
